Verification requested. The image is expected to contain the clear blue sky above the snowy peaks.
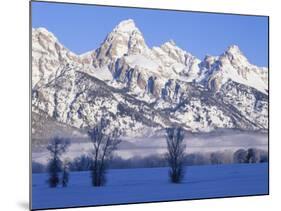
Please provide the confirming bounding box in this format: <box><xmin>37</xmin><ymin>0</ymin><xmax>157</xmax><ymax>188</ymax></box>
<box><xmin>32</xmin><ymin>2</ymin><xmax>268</xmax><ymax>66</ymax></box>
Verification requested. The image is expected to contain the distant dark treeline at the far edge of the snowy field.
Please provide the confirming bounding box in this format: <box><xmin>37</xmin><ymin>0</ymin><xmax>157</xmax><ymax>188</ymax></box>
<box><xmin>32</xmin><ymin>148</ymin><xmax>268</xmax><ymax>173</ymax></box>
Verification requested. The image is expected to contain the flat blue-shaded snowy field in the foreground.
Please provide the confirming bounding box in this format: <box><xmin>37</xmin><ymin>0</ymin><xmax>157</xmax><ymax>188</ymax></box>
<box><xmin>32</xmin><ymin>163</ymin><xmax>268</xmax><ymax>209</ymax></box>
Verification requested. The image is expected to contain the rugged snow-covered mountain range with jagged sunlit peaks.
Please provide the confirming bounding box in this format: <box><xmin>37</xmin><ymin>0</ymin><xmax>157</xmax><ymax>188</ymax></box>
<box><xmin>32</xmin><ymin>19</ymin><xmax>268</xmax><ymax>136</ymax></box>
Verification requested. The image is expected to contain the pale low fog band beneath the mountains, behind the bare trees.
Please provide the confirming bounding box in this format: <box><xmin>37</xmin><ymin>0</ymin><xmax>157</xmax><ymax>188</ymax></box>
<box><xmin>32</xmin><ymin>130</ymin><xmax>268</xmax><ymax>164</ymax></box>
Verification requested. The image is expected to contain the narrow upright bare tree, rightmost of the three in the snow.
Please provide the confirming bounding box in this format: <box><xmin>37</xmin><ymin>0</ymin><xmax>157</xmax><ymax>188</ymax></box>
<box><xmin>166</xmin><ymin>128</ymin><xmax>186</xmax><ymax>183</ymax></box>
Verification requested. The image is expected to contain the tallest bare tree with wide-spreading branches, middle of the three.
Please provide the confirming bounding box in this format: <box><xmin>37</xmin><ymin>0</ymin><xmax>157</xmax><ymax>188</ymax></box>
<box><xmin>88</xmin><ymin>118</ymin><xmax>121</xmax><ymax>186</ymax></box>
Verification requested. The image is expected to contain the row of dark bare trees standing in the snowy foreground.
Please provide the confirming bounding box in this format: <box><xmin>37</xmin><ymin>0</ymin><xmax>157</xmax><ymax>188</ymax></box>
<box><xmin>47</xmin><ymin>118</ymin><xmax>186</xmax><ymax>187</ymax></box>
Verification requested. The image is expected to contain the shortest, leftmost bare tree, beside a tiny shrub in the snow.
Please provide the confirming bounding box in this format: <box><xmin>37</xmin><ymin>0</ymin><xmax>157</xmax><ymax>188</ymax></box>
<box><xmin>47</xmin><ymin>137</ymin><xmax>70</xmax><ymax>187</ymax></box>
